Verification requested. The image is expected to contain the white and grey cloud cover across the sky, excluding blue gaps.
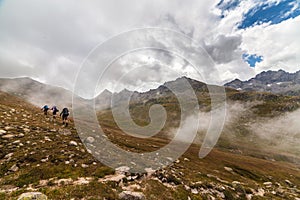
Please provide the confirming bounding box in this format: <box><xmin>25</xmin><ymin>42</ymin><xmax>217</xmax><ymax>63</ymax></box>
<box><xmin>0</xmin><ymin>0</ymin><xmax>300</xmax><ymax>97</ymax></box>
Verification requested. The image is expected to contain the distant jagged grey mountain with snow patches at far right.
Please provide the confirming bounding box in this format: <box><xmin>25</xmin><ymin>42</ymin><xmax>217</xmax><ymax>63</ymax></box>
<box><xmin>224</xmin><ymin>70</ymin><xmax>300</xmax><ymax>96</ymax></box>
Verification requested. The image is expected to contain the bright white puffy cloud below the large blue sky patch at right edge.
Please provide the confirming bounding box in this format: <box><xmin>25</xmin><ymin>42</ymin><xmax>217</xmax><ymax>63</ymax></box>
<box><xmin>242</xmin><ymin>16</ymin><xmax>300</xmax><ymax>73</ymax></box>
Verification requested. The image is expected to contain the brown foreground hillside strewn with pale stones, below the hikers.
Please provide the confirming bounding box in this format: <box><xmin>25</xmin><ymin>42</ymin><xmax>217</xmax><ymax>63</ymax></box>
<box><xmin>0</xmin><ymin>93</ymin><xmax>300</xmax><ymax>200</ymax></box>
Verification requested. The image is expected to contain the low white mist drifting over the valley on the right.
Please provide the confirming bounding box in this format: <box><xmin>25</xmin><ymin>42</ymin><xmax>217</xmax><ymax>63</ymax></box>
<box><xmin>169</xmin><ymin>101</ymin><xmax>300</xmax><ymax>163</ymax></box>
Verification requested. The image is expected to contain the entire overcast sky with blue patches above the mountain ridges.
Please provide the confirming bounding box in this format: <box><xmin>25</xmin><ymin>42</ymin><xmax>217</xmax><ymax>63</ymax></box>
<box><xmin>0</xmin><ymin>0</ymin><xmax>300</xmax><ymax>97</ymax></box>
